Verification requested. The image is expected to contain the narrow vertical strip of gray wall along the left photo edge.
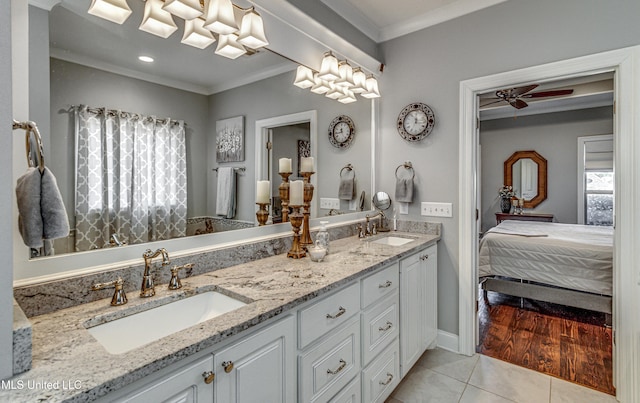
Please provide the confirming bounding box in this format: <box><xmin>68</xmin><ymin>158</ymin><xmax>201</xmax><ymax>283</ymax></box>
<box><xmin>0</xmin><ymin>0</ymin><xmax>15</xmax><ymax>379</ymax></box>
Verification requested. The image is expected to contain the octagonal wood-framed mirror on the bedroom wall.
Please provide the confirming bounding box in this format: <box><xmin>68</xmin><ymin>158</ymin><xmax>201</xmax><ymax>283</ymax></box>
<box><xmin>504</xmin><ymin>151</ymin><xmax>547</xmax><ymax>208</ymax></box>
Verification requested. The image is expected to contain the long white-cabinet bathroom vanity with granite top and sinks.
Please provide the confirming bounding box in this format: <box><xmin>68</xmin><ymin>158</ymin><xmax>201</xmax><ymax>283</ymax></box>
<box><xmin>0</xmin><ymin>223</ymin><xmax>439</xmax><ymax>402</ymax></box>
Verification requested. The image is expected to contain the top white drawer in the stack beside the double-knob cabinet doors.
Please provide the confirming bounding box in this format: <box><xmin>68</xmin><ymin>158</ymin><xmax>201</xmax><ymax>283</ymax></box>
<box><xmin>298</xmin><ymin>282</ymin><xmax>360</xmax><ymax>349</ymax></box>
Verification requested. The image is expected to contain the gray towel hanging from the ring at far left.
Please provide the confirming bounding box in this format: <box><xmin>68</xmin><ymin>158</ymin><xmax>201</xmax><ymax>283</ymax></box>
<box><xmin>16</xmin><ymin>168</ymin><xmax>69</xmax><ymax>248</ymax></box>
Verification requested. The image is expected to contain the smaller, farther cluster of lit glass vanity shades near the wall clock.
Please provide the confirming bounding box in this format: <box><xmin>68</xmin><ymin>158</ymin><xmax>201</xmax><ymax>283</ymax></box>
<box><xmin>293</xmin><ymin>52</ymin><xmax>380</xmax><ymax>104</ymax></box>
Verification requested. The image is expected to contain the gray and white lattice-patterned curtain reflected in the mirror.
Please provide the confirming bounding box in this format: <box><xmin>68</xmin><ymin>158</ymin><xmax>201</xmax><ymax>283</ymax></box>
<box><xmin>75</xmin><ymin>106</ymin><xmax>187</xmax><ymax>251</ymax></box>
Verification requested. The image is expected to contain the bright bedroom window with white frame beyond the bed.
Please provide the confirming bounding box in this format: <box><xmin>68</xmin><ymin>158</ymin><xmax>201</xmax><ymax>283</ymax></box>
<box><xmin>578</xmin><ymin>135</ymin><xmax>614</xmax><ymax>226</ymax></box>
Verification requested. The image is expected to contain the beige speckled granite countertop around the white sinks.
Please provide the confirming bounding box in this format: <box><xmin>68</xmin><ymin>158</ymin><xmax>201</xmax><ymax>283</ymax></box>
<box><xmin>0</xmin><ymin>232</ymin><xmax>439</xmax><ymax>402</ymax></box>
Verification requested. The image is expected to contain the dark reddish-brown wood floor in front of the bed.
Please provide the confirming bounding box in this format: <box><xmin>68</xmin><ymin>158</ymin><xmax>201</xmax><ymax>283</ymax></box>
<box><xmin>477</xmin><ymin>291</ymin><xmax>615</xmax><ymax>395</ymax></box>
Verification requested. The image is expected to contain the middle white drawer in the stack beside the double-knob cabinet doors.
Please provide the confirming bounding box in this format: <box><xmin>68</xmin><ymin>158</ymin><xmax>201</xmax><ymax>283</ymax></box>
<box><xmin>298</xmin><ymin>316</ymin><xmax>360</xmax><ymax>402</ymax></box>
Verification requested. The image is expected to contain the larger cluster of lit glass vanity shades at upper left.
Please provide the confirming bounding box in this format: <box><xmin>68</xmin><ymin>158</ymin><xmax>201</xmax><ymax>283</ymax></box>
<box><xmin>88</xmin><ymin>0</ymin><xmax>269</xmax><ymax>59</ymax></box>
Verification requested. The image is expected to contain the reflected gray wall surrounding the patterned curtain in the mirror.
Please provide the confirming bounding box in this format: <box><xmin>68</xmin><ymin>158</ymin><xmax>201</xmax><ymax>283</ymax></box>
<box><xmin>50</xmin><ymin>58</ymin><xmax>210</xmax><ymax>226</ymax></box>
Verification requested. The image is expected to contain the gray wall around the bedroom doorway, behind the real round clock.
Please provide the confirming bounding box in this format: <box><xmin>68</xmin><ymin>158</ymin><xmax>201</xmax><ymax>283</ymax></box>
<box><xmin>377</xmin><ymin>0</ymin><xmax>640</xmax><ymax>334</ymax></box>
